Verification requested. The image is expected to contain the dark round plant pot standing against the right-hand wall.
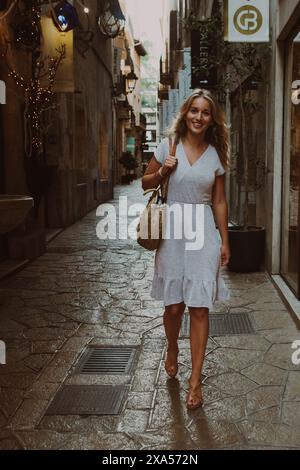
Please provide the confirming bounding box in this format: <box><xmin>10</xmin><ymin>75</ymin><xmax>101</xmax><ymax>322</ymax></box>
<box><xmin>228</xmin><ymin>226</ymin><xmax>266</xmax><ymax>273</ymax></box>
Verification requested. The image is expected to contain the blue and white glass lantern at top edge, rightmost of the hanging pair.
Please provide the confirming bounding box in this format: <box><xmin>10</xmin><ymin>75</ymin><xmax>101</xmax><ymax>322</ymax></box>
<box><xmin>98</xmin><ymin>0</ymin><xmax>126</xmax><ymax>38</ymax></box>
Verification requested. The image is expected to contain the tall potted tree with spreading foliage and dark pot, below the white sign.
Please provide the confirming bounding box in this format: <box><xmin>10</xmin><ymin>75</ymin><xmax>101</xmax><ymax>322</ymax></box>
<box><xmin>186</xmin><ymin>10</ymin><xmax>270</xmax><ymax>272</ymax></box>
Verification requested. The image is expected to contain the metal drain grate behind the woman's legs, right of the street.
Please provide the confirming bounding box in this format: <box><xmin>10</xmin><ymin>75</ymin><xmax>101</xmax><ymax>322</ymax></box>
<box><xmin>181</xmin><ymin>313</ymin><xmax>255</xmax><ymax>336</ymax></box>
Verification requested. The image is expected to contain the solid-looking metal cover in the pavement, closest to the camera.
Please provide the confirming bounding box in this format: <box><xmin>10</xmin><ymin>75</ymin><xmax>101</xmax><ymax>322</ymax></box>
<box><xmin>46</xmin><ymin>385</ymin><xmax>129</xmax><ymax>416</ymax></box>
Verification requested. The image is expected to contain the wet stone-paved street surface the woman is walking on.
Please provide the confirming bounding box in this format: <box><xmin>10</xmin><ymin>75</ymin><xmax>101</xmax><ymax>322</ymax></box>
<box><xmin>0</xmin><ymin>181</ymin><xmax>300</xmax><ymax>450</ymax></box>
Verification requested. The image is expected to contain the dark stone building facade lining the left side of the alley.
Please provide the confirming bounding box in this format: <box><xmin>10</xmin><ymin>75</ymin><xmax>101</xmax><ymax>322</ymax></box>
<box><xmin>0</xmin><ymin>0</ymin><xmax>146</xmax><ymax>259</ymax></box>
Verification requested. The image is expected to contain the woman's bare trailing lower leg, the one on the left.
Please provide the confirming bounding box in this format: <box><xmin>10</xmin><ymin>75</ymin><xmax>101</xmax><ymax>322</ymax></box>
<box><xmin>164</xmin><ymin>302</ymin><xmax>185</xmax><ymax>377</ymax></box>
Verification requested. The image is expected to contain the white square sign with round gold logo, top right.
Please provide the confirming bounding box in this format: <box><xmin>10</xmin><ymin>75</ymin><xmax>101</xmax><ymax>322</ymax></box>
<box><xmin>224</xmin><ymin>0</ymin><xmax>270</xmax><ymax>42</ymax></box>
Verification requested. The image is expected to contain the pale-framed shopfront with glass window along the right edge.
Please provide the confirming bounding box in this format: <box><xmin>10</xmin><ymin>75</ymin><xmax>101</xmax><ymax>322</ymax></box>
<box><xmin>264</xmin><ymin>0</ymin><xmax>300</xmax><ymax>316</ymax></box>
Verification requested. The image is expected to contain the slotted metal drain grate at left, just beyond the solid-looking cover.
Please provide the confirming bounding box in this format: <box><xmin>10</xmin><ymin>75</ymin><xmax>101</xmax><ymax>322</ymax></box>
<box><xmin>74</xmin><ymin>346</ymin><xmax>136</xmax><ymax>375</ymax></box>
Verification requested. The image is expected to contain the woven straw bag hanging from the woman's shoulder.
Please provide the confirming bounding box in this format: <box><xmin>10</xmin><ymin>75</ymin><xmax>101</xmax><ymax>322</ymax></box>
<box><xmin>136</xmin><ymin>139</ymin><xmax>177</xmax><ymax>251</ymax></box>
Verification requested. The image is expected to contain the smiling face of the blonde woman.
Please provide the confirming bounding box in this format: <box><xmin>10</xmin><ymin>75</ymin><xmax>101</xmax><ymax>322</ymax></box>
<box><xmin>185</xmin><ymin>97</ymin><xmax>213</xmax><ymax>136</ymax></box>
